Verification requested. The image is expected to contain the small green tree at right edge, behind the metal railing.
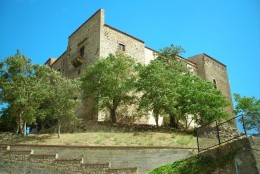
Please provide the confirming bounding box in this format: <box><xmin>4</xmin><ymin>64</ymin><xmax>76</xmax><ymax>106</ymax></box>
<box><xmin>234</xmin><ymin>94</ymin><xmax>260</xmax><ymax>133</ymax></box>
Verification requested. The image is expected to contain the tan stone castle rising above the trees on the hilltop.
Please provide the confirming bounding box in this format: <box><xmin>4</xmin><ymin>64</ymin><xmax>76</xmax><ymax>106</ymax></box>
<box><xmin>45</xmin><ymin>9</ymin><xmax>233</xmax><ymax>123</ymax></box>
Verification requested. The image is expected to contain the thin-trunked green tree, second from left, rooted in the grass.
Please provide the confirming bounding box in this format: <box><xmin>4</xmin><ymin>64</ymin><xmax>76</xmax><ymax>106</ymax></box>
<box><xmin>38</xmin><ymin>71</ymin><xmax>80</xmax><ymax>138</ymax></box>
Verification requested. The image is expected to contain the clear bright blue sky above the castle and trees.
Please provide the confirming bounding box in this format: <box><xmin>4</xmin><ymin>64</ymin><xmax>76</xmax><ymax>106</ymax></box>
<box><xmin>0</xmin><ymin>0</ymin><xmax>260</xmax><ymax>102</ymax></box>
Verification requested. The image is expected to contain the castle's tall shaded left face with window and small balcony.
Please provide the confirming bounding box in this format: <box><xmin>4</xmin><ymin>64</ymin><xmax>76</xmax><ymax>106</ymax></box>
<box><xmin>64</xmin><ymin>10</ymin><xmax>104</xmax><ymax>78</ymax></box>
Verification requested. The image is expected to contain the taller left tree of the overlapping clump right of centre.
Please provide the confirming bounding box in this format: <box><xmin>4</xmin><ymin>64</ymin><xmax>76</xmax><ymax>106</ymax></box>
<box><xmin>137</xmin><ymin>45</ymin><xmax>189</xmax><ymax>126</ymax></box>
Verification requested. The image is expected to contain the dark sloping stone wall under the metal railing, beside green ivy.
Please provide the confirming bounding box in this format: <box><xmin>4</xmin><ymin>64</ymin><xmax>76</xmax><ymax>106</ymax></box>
<box><xmin>200</xmin><ymin>137</ymin><xmax>260</xmax><ymax>174</ymax></box>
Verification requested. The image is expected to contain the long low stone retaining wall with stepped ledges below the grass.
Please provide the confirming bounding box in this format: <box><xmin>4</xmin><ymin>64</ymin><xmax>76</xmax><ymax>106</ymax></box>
<box><xmin>0</xmin><ymin>145</ymin><xmax>195</xmax><ymax>174</ymax></box>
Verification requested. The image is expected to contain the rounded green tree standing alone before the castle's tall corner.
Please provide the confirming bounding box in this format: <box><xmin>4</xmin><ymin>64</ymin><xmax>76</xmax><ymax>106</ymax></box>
<box><xmin>81</xmin><ymin>52</ymin><xmax>136</xmax><ymax>123</ymax></box>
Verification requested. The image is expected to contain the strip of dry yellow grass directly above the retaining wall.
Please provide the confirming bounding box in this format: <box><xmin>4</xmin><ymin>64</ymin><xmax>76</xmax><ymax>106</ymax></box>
<box><xmin>0</xmin><ymin>131</ymin><xmax>196</xmax><ymax>148</ymax></box>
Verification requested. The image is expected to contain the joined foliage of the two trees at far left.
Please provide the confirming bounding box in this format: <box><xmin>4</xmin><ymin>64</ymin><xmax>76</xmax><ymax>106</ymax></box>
<box><xmin>0</xmin><ymin>53</ymin><xmax>80</xmax><ymax>135</ymax></box>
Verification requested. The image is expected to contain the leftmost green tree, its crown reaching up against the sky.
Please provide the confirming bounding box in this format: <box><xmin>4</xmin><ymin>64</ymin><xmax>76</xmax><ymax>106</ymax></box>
<box><xmin>0</xmin><ymin>52</ymin><xmax>48</xmax><ymax>135</ymax></box>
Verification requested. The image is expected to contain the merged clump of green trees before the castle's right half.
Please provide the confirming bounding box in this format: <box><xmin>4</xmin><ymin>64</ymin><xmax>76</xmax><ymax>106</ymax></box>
<box><xmin>137</xmin><ymin>45</ymin><xmax>228</xmax><ymax>129</ymax></box>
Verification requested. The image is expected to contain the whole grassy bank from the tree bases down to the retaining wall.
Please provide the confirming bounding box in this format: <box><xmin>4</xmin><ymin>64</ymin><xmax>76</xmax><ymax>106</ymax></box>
<box><xmin>0</xmin><ymin>123</ymin><xmax>197</xmax><ymax>148</ymax></box>
